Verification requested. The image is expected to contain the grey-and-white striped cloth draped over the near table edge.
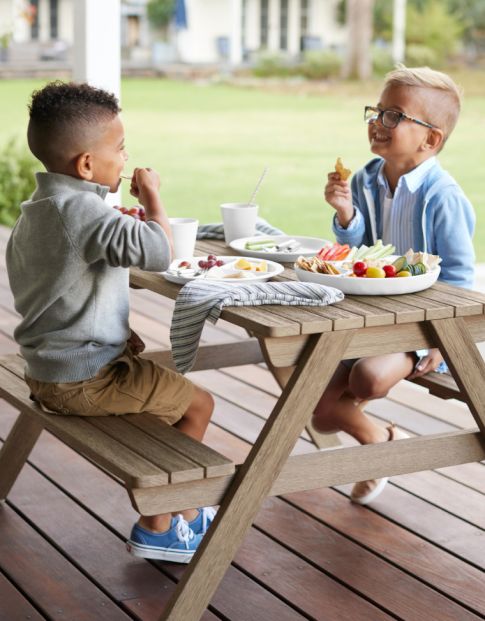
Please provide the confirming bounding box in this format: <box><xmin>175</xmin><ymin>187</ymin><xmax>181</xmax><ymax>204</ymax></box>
<box><xmin>170</xmin><ymin>280</ymin><xmax>344</xmax><ymax>373</ymax></box>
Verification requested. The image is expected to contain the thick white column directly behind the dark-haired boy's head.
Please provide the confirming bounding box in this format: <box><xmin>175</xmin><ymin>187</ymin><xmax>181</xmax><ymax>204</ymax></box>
<box><xmin>73</xmin><ymin>0</ymin><xmax>121</xmax><ymax>98</ymax></box>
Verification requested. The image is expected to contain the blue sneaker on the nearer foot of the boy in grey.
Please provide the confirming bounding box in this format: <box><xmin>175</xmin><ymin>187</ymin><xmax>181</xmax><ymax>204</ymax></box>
<box><xmin>126</xmin><ymin>515</ymin><xmax>202</xmax><ymax>563</ymax></box>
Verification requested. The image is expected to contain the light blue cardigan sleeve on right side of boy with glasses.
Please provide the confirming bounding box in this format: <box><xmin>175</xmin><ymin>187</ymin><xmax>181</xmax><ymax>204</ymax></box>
<box><xmin>433</xmin><ymin>186</ymin><xmax>475</xmax><ymax>288</ymax></box>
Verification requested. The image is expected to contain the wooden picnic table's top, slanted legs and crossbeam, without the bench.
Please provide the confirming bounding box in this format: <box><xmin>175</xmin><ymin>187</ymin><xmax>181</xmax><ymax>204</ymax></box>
<box><xmin>131</xmin><ymin>241</ymin><xmax>485</xmax><ymax>621</ymax></box>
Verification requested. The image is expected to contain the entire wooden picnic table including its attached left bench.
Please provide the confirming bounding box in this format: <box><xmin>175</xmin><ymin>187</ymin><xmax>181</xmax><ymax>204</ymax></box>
<box><xmin>0</xmin><ymin>242</ymin><xmax>485</xmax><ymax>621</ymax></box>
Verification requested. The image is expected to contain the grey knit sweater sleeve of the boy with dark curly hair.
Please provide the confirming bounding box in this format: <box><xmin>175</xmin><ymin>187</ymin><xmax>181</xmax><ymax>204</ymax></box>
<box><xmin>59</xmin><ymin>194</ymin><xmax>170</xmax><ymax>271</ymax></box>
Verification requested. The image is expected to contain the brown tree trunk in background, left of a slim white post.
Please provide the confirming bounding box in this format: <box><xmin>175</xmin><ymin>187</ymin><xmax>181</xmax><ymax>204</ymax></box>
<box><xmin>343</xmin><ymin>0</ymin><xmax>374</xmax><ymax>80</ymax></box>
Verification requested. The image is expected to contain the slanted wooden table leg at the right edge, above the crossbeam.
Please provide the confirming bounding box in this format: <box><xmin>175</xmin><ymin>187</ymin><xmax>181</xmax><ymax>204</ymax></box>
<box><xmin>430</xmin><ymin>317</ymin><xmax>485</xmax><ymax>435</ymax></box>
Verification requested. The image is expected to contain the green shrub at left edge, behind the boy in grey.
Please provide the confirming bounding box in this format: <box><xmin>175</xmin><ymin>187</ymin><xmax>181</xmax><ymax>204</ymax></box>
<box><xmin>0</xmin><ymin>139</ymin><xmax>39</xmax><ymax>226</ymax></box>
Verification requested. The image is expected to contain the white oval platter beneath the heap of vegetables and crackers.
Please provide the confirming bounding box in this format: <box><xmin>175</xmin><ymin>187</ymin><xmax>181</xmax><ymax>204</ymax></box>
<box><xmin>294</xmin><ymin>264</ymin><xmax>440</xmax><ymax>295</ymax></box>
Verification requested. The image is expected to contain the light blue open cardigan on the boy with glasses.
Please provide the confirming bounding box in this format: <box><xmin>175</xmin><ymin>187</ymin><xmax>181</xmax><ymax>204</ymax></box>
<box><xmin>333</xmin><ymin>158</ymin><xmax>475</xmax><ymax>288</ymax></box>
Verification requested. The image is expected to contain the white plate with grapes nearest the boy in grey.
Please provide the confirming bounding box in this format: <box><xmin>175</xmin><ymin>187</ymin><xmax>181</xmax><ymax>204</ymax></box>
<box><xmin>162</xmin><ymin>256</ymin><xmax>284</xmax><ymax>285</ymax></box>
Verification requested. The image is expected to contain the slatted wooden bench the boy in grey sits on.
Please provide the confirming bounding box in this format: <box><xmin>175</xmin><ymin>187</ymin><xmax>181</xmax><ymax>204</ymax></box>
<box><xmin>0</xmin><ymin>355</ymin><xmax>235</xmax><ymax>515</ymax></box>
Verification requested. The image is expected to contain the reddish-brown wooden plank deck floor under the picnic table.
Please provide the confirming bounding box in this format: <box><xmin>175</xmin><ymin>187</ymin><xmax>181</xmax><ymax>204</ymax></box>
<box><xmin>0</xmin><ymin>228</ymin><xmax>485</xmax><ymax>621</ymax></box>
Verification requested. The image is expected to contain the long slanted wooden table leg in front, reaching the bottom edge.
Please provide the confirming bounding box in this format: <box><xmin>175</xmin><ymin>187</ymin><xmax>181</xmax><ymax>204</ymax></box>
<box><xmin>160</xmin><ymin>330</ymin><xmax>353</xmax><ymax>621</ymax></box>
